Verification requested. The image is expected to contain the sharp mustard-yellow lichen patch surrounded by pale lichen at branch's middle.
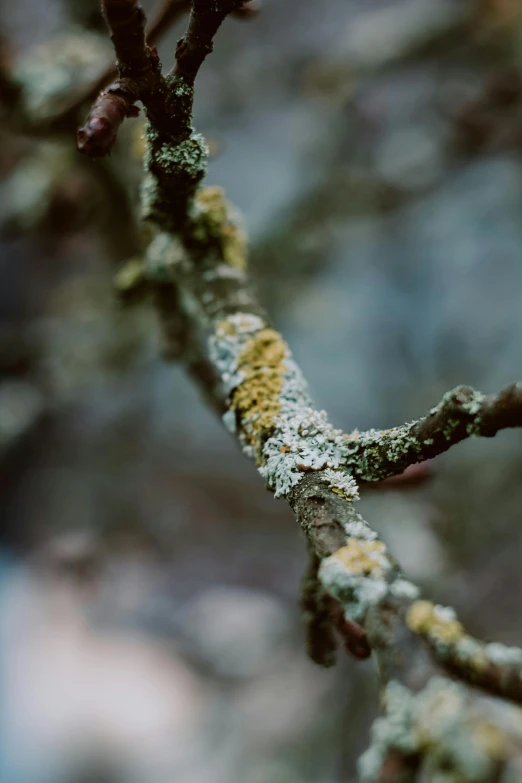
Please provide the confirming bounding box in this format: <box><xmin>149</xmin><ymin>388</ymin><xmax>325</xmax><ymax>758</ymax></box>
<box><xmin>231</xmin><ymin>328</ymin><xmax>288</xmax><ymax>444</ymax></box>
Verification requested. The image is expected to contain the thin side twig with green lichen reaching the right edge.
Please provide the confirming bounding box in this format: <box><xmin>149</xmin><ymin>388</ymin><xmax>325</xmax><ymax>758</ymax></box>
<box><xmin>351</xmin><ymin>383</ymin><xmax>522</xmax><ymax>481</ymax></box>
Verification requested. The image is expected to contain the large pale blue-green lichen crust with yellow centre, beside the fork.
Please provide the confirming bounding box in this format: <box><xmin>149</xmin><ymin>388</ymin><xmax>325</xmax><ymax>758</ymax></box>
<box><xmin>210</xmin><ymin>314</ymin><xmax>355</xmax><ymax>499</ymax></box>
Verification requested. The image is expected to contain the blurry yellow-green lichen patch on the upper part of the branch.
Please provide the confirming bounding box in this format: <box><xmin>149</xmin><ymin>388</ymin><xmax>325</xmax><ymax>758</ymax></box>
<box><xmin>195</xmin><ymin>186</ymin><xmax>247</xmax><ymax>269</ymax></box>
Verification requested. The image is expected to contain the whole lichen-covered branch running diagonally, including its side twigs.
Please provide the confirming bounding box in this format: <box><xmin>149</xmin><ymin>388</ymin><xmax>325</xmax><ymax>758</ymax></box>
<box><xmin>76</xmin><ymin>0</ymin><xmax>522</xmax><ymax>783</ymax></box>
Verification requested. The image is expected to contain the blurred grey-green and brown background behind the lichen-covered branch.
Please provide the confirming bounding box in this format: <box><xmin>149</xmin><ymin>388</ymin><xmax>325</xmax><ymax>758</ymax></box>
<box><xmin>0</xmin><ymin>0</ymin><xmax>522</xmax><ymax>783</ymax></box>
